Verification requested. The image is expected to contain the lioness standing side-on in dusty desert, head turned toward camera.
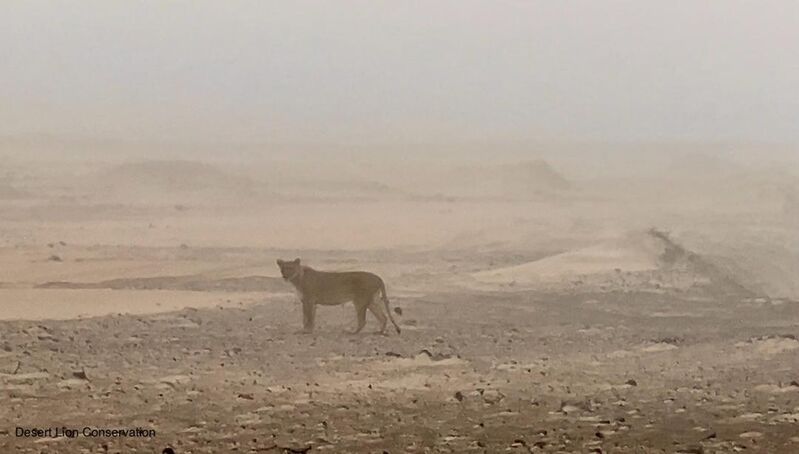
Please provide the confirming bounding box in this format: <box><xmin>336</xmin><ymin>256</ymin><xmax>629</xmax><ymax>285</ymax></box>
<box><xmin>277</xmin><ymin>259</ymin><xmax>400</xmax><ymax>334</ymax></box>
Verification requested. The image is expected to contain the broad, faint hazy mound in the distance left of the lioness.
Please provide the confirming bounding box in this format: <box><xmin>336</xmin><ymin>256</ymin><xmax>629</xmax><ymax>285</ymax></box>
<box><xmin>90</xmin><ymin>161</ymin><xmax>264</xmax><ymax>201</ymax></box>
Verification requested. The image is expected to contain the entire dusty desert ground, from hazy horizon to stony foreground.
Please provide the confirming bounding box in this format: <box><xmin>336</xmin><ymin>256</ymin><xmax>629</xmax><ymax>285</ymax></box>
<box><xmin>0</xmin><ymin>142</ymin><xmax>799</xmax><ymax>454</ymax></box>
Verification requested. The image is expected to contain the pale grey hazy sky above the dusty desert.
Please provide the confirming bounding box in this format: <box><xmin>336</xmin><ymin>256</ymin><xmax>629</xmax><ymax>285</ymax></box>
<box><xmin>0</xmin><ymin>0</ymin><xmax>799</xmax><ymax>142</ymax></box>
